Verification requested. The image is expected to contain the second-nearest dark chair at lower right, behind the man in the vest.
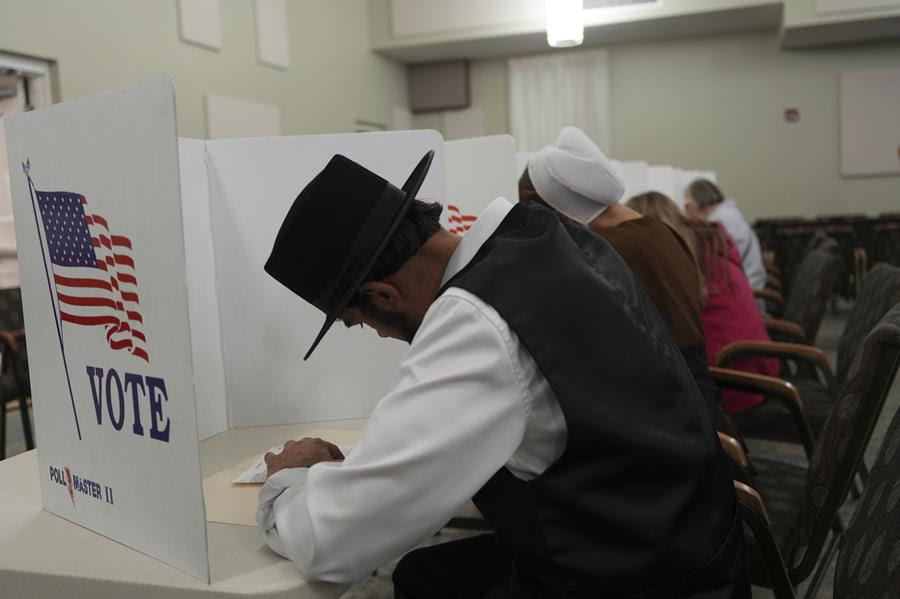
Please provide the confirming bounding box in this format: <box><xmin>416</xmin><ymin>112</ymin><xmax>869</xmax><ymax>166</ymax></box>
<box><xmin>724</xmin><ymin>305</ymin><xmax>900</xmax><ymax>597</ymax></box>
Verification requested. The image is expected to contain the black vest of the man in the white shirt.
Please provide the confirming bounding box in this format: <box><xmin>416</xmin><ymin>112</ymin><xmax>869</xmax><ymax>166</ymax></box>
<box><xmin>444</xmin><ymin>204</ymin><xmax>743</xmax><ymax>598</ymax></box>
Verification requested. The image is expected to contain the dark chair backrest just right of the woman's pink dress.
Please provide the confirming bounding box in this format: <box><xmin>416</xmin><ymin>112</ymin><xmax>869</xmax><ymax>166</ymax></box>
<box><xmin>781</xmin><ymin>250</ymin><xmax>841</xmax><ymax>343</ymax></box>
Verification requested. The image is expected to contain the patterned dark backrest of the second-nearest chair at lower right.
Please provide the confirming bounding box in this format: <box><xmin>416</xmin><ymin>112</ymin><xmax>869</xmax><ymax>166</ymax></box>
<box><xmin>791</xmin><ymin>304</ymin><xmax>900</xmax><ymax>580</ymax></box>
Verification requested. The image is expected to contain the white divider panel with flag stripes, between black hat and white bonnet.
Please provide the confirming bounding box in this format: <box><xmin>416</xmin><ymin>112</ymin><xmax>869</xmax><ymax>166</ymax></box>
<box><xmin>441</xmin><ymin>135</ymin><xmax>519</xmax><ymax>235</ymax></box>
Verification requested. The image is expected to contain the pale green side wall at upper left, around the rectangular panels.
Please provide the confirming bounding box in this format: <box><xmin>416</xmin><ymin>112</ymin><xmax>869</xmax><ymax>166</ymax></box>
<box><xmin>0</xmin><ymin>0</ymin><xmax>407</xmax><ymax>137</ymax></box>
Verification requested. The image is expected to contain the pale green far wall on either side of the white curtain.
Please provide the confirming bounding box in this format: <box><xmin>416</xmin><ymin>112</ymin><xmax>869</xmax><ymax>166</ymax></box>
<box><xmin>414</xmin><ymin>32</ymin><xmax>900</xmax><ymax>218</ymax></box>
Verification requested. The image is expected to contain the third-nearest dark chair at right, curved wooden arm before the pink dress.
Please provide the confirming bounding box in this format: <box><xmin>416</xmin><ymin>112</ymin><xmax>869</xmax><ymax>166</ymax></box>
<box><xmin>715</xmin><ymin>264</ymin><xmax>900</xmax><ymax>444</ymax></box>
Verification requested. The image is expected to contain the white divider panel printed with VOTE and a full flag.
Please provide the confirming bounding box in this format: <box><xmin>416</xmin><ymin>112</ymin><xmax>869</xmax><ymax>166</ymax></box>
<box><xmin>7</xmin><ymin>76</ymin><xmax>209</xmax><ymax>581</ymax></box>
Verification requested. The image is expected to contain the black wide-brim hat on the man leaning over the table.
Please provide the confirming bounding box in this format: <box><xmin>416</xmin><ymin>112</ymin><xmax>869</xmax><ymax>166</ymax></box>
<box><xmin>265</xmin><ymin>150</ymin><xmax>434</xmax><ymax>360</ymax></box>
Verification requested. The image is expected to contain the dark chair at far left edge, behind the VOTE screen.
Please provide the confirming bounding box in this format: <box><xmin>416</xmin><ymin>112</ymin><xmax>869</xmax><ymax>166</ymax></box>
<box><xmin>0</xmin><ymin>288</ymin><xmax>34</xmax><ymax>460</ymax></box>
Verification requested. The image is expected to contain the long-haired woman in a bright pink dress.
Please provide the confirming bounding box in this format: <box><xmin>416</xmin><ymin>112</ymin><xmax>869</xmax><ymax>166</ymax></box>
<box><xmin>628</xmin><ymin>192</ymin><xmax>779</xmax><ymax>414</ymax></box>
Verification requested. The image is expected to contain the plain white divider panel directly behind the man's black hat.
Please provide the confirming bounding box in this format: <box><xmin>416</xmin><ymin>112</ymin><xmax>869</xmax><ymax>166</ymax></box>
<box><xmin>207</xmin><ymin>131</ymin><xmax>446</xmax><ymax>428</ymax></box>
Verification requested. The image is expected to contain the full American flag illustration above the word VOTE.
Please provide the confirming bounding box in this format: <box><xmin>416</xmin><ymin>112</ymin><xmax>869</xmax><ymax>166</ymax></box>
<box><xmin>35</xmin><ymin>190</ymin><xmax>150</xmax><ymax>362</ymax></box>
